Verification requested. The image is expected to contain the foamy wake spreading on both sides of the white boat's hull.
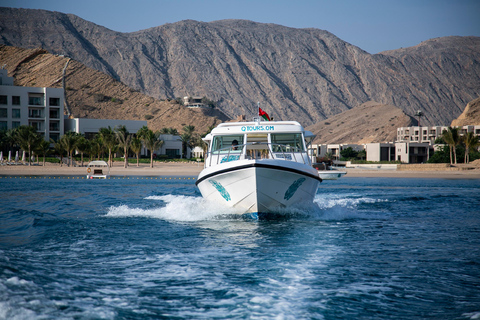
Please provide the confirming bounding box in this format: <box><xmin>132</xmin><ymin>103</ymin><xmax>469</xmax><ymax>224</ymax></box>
<box><xmin>106</xmin><ymin>195</ymin><xmax>388</xmax><ymax>222</ymax></box>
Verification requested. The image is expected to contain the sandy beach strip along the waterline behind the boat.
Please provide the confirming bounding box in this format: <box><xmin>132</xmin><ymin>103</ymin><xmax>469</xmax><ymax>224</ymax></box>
<box><xmin>0</xmin><ymin>162</ymin><xmax>480</xmax><ymax>180</ymax></box>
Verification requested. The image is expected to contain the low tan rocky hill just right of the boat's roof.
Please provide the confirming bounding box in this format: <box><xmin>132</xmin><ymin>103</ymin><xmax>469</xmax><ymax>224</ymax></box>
<box><xmin>307</xmin><ymin>101</ymin><xmax>417</xmax><ymax>144</ymax></box>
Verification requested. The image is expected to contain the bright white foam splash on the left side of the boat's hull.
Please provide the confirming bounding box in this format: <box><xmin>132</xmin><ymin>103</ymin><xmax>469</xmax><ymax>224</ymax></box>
<box><xmin>107</xmin><ymin>195</ymin><xmax>246</xmax><ymax>221</ymax></box>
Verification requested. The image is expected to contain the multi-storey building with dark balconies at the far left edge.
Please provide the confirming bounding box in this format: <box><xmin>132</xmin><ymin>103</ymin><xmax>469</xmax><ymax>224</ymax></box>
<box><xmin>0</xmin><ymin>69</ymin><xmax>64</xmax><ymax>141</ymax></box>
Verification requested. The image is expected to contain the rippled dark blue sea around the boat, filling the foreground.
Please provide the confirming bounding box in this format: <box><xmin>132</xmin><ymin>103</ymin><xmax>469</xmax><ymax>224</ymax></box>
<box><xmin>0</xmin><ymin>176</ymin><xmax>480</xmax><ymax>319</ymax></box>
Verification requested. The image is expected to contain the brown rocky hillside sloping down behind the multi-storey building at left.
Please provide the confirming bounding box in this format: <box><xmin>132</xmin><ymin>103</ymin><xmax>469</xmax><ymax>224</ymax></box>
<box><xmin>0</xmin><ymin>45</ymin><xmax>221</xmax><ymax>134</ymax></box>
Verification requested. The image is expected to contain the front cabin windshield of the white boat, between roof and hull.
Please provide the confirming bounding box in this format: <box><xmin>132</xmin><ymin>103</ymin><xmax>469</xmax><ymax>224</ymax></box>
<box><xmin>205</xmin><ymin>142</ymin><xmax>311</xmax><ymax>167</ymax></box>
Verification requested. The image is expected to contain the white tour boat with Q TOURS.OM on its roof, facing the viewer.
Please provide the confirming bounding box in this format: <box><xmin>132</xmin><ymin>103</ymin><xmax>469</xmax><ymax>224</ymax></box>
<box><xmin>196</xmin><ymin>119</ymin><xmax>322</xmax><ymax>214</ymax></box>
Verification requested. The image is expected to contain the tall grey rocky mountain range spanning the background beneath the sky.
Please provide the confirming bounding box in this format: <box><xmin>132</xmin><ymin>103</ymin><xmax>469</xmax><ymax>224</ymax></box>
<box><xmin>0</xmin><ymin>8</ymin><xmax>480</xmax><ymax>125</ymax></box>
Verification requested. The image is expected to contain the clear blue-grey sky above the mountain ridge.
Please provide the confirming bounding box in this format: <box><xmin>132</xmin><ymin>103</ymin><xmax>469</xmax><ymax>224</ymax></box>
<box><xmin>0</xmin><ymin>0</ymin><xmax>480</xmax><ymax>53</ymax></box>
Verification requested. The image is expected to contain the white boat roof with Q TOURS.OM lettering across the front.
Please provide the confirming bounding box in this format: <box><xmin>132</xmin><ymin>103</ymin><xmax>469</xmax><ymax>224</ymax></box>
<box><xmin>203</xmin><ymin>121</ymin><xmax>315</xmax><ymax>141</ymax></box>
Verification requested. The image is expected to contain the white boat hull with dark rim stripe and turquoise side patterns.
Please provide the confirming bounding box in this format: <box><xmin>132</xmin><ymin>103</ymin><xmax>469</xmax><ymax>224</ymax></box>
<box><xmin>197</xmin><ymin>160</ymin><xmax>321</xmax><ymax>214</ymax></box>
